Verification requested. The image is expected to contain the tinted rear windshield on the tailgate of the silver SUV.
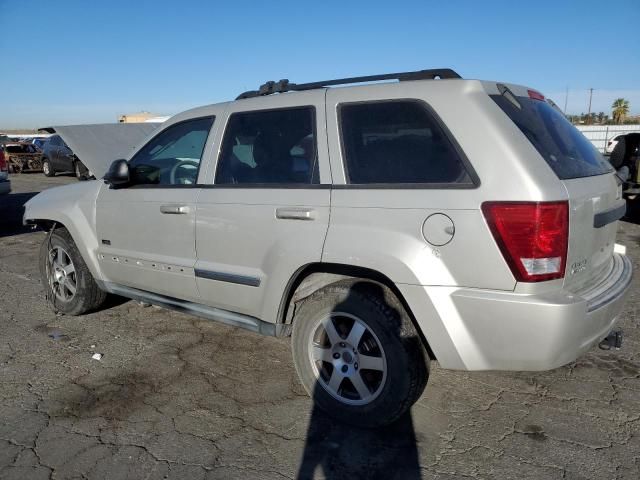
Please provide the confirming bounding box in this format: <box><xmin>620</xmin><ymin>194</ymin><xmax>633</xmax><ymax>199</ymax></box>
<box><xmin>491</xmin><ymin>91</ymin><xmax>612</xmax><ymax>180</ymax></box>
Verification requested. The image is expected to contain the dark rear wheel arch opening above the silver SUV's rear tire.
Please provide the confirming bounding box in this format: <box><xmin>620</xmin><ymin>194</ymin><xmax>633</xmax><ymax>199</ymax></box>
<box><xmin>277</xmin><ymin>263</ymin><xmax>436</xmax><ymax>360</ymax></box>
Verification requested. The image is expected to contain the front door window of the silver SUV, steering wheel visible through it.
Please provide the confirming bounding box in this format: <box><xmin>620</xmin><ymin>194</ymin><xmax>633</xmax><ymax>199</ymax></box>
<box><xmin>129</xmin><ymin>117</ymin><xmax>214</xmax><ymax>185</ymax></box>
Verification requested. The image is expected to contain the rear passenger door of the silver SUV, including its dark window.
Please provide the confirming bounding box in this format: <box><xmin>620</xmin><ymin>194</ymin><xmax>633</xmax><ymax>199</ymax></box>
<box><xmin>196</xmin><ymin>90</ymin><xmax>331</xmax><ymax>322</ymax></box>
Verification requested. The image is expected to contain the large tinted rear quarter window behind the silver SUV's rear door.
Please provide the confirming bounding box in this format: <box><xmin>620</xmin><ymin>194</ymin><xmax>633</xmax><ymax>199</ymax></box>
<box><xmin>339</xmin><ymin>100</ymin><xmax>473</xmax><ymax>185</ymax></box>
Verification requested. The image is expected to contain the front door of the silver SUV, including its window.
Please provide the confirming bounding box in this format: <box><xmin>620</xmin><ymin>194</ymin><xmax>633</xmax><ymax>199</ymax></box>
<box><xmin>96</xmin><ymin>115</ymin><xmax>214</xmax><ymax>300</ymax></box>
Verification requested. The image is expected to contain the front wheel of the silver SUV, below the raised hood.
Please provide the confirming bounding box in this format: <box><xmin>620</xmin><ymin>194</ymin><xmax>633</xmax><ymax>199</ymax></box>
<box><xmin>40</xmin><ymin>228</ymin><xmax>107</xmax><ymax>316</ymax></box>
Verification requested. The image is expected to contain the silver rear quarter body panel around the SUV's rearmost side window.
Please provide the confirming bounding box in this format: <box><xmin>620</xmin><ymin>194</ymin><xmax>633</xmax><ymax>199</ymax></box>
<box><xmin>323</xmin><ymin>80</ymin><xmax>566</xmax><ymax>290</ymax></box>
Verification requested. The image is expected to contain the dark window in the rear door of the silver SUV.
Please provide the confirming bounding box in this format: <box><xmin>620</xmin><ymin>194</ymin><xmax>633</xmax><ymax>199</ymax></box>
<box><xmin>215</xmin><ymin>107</ymin><xmax>318</xmax><ymax>185</ymax></box>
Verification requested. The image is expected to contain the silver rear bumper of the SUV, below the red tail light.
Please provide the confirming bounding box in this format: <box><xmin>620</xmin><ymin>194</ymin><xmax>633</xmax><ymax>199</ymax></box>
<box><xmin>399</xmin><ymin>254</ymin><xmax>633</xmax><ymax>371</ymax></box>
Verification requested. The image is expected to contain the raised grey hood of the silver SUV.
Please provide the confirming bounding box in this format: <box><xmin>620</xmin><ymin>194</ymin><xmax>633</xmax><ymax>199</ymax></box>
<box><xmin>40</xmin><ymin>123</ymin><xmax>161</xmax><ymax>178</ymax></box>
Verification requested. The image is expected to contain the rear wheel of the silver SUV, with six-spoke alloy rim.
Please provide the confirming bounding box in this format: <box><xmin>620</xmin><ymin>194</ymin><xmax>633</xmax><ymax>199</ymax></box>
<box><xmin>292</xmin><ymin>280</ymin><xmax>429</xmax><ymax>428</ymax></box>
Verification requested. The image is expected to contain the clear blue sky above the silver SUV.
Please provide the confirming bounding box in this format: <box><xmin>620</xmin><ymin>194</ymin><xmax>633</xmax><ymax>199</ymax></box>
<box><xmin>0</xmin><ymin>0</ymin><xmax>640</xmax><ymax>129</ymax></box>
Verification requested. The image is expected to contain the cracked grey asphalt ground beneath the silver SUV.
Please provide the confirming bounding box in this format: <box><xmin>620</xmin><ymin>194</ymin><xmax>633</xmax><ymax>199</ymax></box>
<box><xmin>0</xmin><ymin>174</ymin><xmax>640</xmax><ymax>480</ymax></box>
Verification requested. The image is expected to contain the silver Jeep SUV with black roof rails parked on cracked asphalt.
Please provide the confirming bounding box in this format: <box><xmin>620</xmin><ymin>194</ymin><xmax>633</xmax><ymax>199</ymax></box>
<box><xmin>25</xmin><ymin>69</ymin><xmax>632</xmax><ymax>426</ymax></box>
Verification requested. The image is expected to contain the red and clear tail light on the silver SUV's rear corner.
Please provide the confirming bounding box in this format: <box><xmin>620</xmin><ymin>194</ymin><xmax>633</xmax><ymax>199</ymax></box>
<box><xmin>482</xmin><ymin>202</ymin><xmax>569</xmax><ymax>282</ymax></box>
